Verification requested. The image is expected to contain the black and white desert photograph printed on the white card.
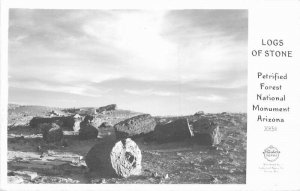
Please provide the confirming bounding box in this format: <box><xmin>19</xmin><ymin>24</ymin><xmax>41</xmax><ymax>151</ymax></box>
<box><xmin>7</xmin><ymin>8</ymin><xmax>248</xmax><ymax>184</ymax></box>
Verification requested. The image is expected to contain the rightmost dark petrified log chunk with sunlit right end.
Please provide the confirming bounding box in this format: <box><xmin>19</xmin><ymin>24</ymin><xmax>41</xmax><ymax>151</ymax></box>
<box><xmin>192</xmin><ymin>118</ymin><xmax>221</xmax><ymax>145</ymax></box>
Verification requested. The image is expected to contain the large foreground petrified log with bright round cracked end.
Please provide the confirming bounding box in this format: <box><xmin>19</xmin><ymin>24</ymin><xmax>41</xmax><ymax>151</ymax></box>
<box><xmin>85</xmin><ymin>138</ymin><xmax>142</xmax><ymax>178</ymax></box>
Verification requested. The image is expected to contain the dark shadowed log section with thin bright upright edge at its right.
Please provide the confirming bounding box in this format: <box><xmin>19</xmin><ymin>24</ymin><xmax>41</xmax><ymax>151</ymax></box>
<box><xmin>153</xmin><ymin>118</ymin><xmax>193</xmax><ymax>142</ymax></box>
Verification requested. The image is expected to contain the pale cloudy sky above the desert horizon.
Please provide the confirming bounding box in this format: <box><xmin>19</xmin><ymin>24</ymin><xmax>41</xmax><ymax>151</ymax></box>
<box><xmin>8</xmin><ymin>9</ymin><xmax>248</xmax><ymax>115</ymax></box>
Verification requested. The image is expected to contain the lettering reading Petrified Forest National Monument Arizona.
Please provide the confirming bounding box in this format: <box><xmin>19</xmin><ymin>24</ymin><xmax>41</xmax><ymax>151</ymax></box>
<box><xmin>252</xmin><ymin>72</ymin><xmax>290</xmax><ymax>123</ymax></box>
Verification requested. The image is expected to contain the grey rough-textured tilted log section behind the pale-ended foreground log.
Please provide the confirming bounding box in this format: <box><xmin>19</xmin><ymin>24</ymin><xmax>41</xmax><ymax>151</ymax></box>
<box><xmin>114</xmin><ymin>114</ymin><xmax>156</xmax><ymax>139</ymax></box>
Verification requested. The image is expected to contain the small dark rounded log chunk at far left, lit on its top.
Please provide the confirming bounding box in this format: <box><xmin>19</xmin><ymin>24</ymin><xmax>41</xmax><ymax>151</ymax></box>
<box><xmin>42</xmin><ymin>123</ymin><xmax>64</xmax><ymax>142</ymax></box>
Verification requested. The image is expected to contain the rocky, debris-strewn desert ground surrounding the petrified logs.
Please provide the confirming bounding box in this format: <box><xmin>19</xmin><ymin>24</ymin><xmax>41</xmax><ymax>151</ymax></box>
<box><xmin>8</xmin><ymin>105</ymin><xmax>247</xmax><ymax>184</ymax></box>
